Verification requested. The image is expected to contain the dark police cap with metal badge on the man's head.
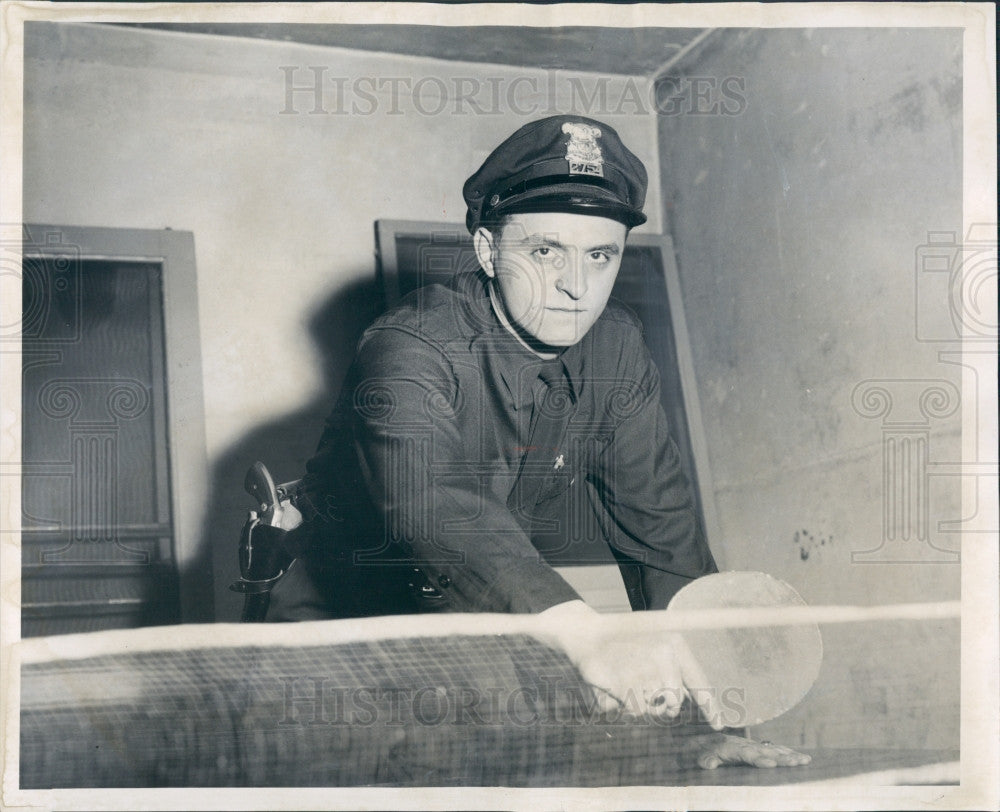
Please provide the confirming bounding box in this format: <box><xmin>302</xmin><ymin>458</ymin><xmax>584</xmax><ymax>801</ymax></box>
<box><xmin>462</xmin><ymin>115</ymin><xmax>647</xmax><ymax>232</ymax></box>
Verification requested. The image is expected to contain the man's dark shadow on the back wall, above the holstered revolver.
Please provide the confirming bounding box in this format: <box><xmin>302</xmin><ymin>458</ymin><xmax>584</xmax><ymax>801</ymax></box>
<box><xmin>180</xmin><ymin>272</ymin><xmax>383</xmax><ymax>623</ymax></box>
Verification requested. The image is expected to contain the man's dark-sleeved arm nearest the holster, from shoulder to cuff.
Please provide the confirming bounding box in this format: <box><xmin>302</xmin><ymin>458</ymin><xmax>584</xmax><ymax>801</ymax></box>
<box><xmin>353</xmin><ymin>328</ymin><xmax>579</xmax><ymax>612</ymax></box>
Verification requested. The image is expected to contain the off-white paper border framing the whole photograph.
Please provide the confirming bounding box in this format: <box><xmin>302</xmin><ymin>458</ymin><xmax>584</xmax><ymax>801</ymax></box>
<box><xmin>0</xmin><ymin>2</ymin><xmax>1000</xmax><ymax>809</ymax></box>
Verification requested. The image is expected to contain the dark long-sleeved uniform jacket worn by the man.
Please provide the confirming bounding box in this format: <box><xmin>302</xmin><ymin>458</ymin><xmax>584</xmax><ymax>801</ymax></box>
<box><xmin>269</xmin><ymin>272</ymin><xmax>716</xmax><ymax>620</ymax></box>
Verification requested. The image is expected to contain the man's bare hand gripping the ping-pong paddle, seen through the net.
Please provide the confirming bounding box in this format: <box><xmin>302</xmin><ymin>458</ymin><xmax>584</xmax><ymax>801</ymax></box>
<box><xmin>538</xmin><ymin>601</ymin><xmax>723</xmax><ymax>730</ymax></box>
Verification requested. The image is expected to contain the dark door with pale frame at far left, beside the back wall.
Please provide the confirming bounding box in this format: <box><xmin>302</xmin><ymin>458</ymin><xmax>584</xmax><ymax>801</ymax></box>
<box><xmin>21</xmin><ymin>226</ymin><xmax>210</xmax><ymax>637</ymax></box>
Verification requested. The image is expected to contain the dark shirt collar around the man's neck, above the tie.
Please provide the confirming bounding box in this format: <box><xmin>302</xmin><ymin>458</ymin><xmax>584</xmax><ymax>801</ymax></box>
<box><xmin>456</xmin><ymin>270</ymin><xmax>583</xmax><ymax>409</ymax></box>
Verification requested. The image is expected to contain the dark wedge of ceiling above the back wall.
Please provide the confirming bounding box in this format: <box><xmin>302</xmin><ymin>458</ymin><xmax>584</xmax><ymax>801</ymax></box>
<box><xmin>117</xmin><ymin>23</ymin><xmax>705</xmax><ymax>76</ymax></box>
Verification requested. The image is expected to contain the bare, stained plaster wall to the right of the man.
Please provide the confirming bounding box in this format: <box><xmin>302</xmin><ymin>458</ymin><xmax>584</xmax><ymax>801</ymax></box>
<box><xmin>659</xmin><ymin>29</ymin><xmax>963</xmax><ymax>747</ymax></box>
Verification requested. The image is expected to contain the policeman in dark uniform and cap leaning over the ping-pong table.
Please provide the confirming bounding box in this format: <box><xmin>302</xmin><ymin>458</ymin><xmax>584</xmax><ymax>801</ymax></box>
<box><xmin>268</xmin><ymin>116</ymin><xmax>805</xmax><ymax>766</ymax></box>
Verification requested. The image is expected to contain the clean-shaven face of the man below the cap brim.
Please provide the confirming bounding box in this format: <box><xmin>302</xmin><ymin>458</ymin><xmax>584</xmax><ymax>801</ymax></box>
<box><xmin>476</xmin><ymin>212</ymin><xmax>627</xmax><ymax>348</ymax></box>
